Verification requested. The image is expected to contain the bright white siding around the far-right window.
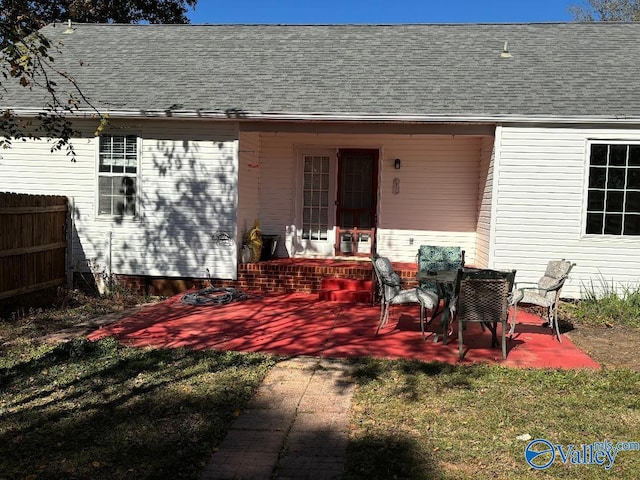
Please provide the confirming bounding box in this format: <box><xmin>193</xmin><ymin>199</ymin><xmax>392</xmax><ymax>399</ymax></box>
<box><xmin>491</xmin><ymin>126</ymin><xmax>640</xmax><ymax>298</ymax></box>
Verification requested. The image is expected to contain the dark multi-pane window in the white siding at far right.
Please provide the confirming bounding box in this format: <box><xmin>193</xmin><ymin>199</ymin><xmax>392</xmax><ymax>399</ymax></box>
<box><xmin>585</xmin><ymin>141</ymin><xmax>640</xmax><ymax>236</ymax></box>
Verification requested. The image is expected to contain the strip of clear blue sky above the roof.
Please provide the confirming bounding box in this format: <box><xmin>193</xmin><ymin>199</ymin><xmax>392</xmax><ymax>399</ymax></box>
<box><xmin>189</xmin><ymin>0</ymin><xmax>583</xmax><ymax>24</ymax></box>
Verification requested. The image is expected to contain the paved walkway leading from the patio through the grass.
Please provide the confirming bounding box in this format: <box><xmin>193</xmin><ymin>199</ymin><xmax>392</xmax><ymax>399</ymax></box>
<box><xmin>201</xmin><ymin>357</ymin><xmax>354</xmax><ymax>480</ymax></box>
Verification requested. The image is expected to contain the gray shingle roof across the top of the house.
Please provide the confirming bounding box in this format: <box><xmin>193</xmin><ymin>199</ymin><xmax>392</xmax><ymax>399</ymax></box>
<box><xmin>0</xmin><ymin>23</ymin><xmax>640</xmax><ymax>119</ymax></box>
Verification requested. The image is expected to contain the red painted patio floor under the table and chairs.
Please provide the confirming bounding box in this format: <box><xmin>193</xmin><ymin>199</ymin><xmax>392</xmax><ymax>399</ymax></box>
<box><xmin>89</xmin><ymin>292</ymin><xmax>600</xmax><ymax>369</ymax></box>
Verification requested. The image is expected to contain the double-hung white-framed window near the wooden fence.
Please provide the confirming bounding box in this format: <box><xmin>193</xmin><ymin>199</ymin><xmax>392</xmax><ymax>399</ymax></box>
<box><xmin>98</xmin><ymin>134</ymin><xmax>140</xmax><ymax>217</ymax></box>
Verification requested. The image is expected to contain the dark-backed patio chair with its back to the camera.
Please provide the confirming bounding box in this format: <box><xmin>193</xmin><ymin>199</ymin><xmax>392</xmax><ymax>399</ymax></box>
<box><xmin>449</xmin><ymin>268</ymin><xmax>516</xmax><ymax>359</ymax></box>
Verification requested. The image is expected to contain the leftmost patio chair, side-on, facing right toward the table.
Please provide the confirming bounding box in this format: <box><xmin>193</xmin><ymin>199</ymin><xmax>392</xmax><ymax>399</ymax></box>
<box><xmin>371</xmin><ymin>255</ymin><xmax>438</xmax><ymax>337</ymax></box>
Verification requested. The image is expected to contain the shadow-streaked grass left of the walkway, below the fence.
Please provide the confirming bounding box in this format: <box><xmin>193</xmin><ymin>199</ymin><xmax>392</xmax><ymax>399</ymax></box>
<box><xmin>0</xmin><ymin>290</ymin><xmax>276</xmax><ymax>480</ymax></box>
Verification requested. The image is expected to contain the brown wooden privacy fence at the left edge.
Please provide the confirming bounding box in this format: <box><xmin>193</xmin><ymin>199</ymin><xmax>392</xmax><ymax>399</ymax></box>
<box><xmin>0</xmin><ymin>192</ymin><xmax>67</xmax><ymax>300</ymax></box>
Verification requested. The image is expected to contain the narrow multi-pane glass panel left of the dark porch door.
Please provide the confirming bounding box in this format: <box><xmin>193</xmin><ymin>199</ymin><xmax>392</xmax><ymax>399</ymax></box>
<box><xmin>302</xmin><ymin>155</ymin><xmax>330</xmax><ymax>240</ymax></box>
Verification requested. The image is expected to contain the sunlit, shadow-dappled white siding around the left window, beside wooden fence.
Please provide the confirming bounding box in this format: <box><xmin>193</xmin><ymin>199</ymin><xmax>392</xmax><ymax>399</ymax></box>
<box><xmin>0</xmin><ymin>120</ymin><xmax>238</xmax><ymax>278</ymax></box>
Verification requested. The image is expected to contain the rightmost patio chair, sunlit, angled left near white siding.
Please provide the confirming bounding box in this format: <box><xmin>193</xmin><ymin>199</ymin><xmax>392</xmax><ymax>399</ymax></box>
<box><xmin>510</xmin><ymin>258</ymin><xmax>576</xmax><ymax>343</ymax></box>
